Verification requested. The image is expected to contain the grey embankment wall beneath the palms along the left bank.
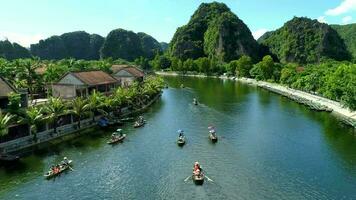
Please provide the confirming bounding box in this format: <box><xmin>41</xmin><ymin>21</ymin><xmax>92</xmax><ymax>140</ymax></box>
<box><xmin>0</xmin><ymin>92</ymin><xmax>162</xmax><ymax>155</ymax></box>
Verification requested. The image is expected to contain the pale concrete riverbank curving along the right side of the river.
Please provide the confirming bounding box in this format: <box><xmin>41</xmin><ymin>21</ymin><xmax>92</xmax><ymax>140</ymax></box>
<box><xmin>156</xmin><ymin>72</ymin><xmax>356</xmax><ymax>128</ymax></box>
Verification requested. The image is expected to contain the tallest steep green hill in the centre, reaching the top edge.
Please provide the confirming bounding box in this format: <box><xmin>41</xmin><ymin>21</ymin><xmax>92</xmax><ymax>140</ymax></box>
<box><xmin>169</xmin><ymin>2</ymin><xmax>260</xmax><ymax>61</ymax></box>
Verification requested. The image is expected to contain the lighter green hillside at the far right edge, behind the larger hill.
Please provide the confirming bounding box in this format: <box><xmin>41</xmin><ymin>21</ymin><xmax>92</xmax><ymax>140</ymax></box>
<box><xmin>331</xmin><ymin>23</ymin><xmax>356</xmax><ymax>60</ymax></box>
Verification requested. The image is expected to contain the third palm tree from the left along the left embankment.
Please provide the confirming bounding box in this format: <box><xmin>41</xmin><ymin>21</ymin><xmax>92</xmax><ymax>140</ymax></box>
<box><xmin>44</xmin><ymin>97</ymin><xmax>66</xmax><ymax>133</ymax></box>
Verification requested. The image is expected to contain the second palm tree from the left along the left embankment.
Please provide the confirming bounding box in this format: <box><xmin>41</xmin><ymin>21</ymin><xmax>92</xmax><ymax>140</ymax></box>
<box><xmin>20</xmin><ymin>107</ymin><xmax>43</xmax><ymax>142</ymax></box>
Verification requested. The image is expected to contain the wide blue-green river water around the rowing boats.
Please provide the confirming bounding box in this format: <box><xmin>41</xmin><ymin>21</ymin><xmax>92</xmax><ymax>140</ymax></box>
<box><xmin>0</xmin><ymin>77</ymin><xmax>356</xmax><ymax>200</ymax></box>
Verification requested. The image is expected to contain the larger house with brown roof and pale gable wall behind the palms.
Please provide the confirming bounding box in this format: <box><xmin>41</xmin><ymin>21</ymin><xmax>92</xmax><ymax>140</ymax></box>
<box><xmin>52</xmin><ymin>71</ymin><xmax>120</xmax><ymax>99</ymax></box>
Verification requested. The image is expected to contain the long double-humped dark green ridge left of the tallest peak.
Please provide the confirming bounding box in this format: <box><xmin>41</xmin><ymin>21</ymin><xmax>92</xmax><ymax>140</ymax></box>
<box><xmin>31</xmin><ymin>29</ymin><xmax>161</xmax><ymax>61</ymax></box>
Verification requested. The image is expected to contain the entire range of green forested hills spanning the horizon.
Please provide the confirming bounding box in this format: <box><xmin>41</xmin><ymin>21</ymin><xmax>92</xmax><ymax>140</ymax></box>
<box><xmin>0</xmin><ymin>2</ymin><xmax>356</xmax><ymax>63</ymax></box>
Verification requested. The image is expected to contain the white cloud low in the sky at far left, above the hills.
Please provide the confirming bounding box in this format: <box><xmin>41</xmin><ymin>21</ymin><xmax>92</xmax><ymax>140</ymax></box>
<box><xmin>0</xmin><ymin>30</ymin><xmax>45</xmax><ymax>47</ymax></box>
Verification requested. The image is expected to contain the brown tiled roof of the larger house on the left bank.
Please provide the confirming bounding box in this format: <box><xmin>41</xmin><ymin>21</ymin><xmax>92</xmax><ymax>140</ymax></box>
<box><xmin>71</xmin><ymin>71</ymin><xmax>118</xmax><ymax>85</ymax></box>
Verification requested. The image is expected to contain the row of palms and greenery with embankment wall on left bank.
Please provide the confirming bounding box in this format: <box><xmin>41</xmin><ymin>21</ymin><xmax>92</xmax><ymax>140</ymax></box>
<box><xmin>0</xmin><ymin>76</ymin><xmax>164</xmax><ymax>154</ymax></box>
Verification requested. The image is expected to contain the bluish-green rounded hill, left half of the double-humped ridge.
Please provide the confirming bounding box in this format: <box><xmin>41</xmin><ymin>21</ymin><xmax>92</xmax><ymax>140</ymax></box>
<box><xmin>31</xmin><ymin>31</ymin><xmax>104</xmax><ymax>60</ymax></box>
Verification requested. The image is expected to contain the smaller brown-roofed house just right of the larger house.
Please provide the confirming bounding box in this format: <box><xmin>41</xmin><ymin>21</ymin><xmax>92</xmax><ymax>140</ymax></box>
<box><xmin>111</xmin><ymin>65</ymin><xmax>145</xmax><ymax>86</ymax></box>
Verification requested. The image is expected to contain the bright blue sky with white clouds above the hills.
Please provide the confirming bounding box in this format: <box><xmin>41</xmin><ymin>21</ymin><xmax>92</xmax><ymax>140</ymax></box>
<box><xmin>0</xmin><ymin>0</ymin><xmax>356</xmax><ymax>47</ymax></box>
